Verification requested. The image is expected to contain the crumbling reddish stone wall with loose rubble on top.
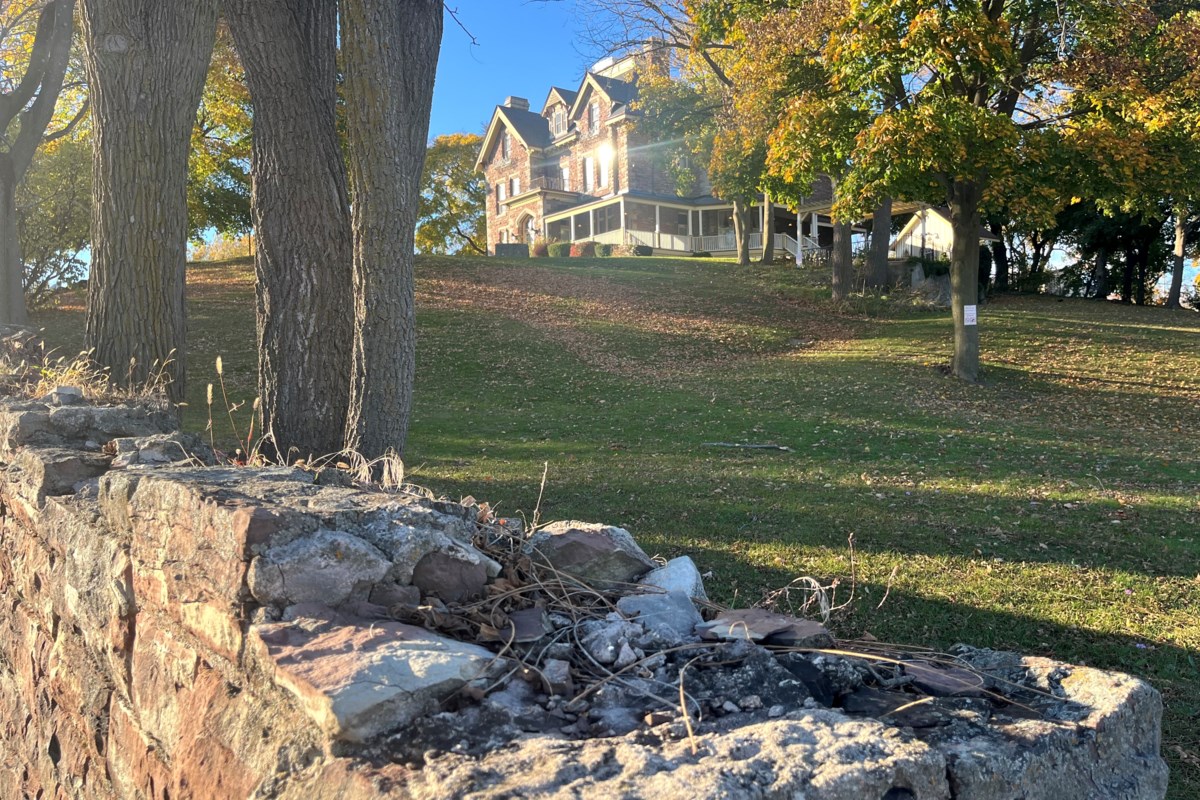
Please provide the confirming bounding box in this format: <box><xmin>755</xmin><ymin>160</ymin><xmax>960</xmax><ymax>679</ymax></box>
<box><xmin>0</xmin><ymin>390</ymin><xmax>1166</xmax><ymax>800</ymax></box>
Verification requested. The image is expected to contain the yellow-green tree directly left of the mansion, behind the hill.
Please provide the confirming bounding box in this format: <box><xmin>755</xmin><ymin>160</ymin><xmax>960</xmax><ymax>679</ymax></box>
<box><xmin>416</xmin><ymin>133</ymin><xmax>487</xmax><ymax>255</ymax></box>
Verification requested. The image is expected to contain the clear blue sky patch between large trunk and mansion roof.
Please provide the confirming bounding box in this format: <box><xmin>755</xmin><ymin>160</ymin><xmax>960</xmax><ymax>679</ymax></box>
<box><xmin>430</xmin><ymin>0</ymin><xmax>594</xmax><ymax>138</ymax></box>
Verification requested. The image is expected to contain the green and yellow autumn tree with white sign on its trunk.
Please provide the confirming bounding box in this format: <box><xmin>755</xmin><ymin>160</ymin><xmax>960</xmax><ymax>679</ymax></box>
<box><xmin>768</xmin><ymin>0</ymin><xmax>1190</xmax><ymax>381</ymax></box>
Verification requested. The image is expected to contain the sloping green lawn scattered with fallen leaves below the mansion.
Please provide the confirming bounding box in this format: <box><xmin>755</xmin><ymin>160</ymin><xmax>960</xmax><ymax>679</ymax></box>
<box><xmin>28</xmin><ymin>258</ymin><xmax>1200</xmax><ymax>798</ymax></box>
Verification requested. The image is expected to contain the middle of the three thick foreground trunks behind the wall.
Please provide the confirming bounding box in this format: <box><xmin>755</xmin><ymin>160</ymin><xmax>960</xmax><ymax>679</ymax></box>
<box><xmin>224</xmin><ymin>0</ymin><xmax>354</xmax><ymax>461</ymax></box>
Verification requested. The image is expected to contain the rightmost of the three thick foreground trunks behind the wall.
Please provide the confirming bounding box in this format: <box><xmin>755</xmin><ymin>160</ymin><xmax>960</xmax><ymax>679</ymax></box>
<box><xmin>342</xmin><ymin>0</ymin><xmax>442</xmax><ymax>458</ymax></box>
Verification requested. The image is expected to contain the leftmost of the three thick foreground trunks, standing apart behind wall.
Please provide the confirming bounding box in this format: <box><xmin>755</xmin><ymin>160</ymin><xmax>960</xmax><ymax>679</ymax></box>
<box><xmin>82</xmin><ymin>0</ymin><xmax>217</xmax><ymax>399</ymax></box>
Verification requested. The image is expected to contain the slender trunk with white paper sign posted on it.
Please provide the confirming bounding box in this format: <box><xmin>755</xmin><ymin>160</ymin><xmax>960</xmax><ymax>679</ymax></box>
<box><xmin>949</xmin><ymin>181</ymin><xmax>982</xmax><ymax>383</ymax></box>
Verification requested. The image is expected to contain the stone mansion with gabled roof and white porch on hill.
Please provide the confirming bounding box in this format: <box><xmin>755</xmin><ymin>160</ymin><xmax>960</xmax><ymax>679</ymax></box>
<box><xmin>475</xmin><ymin>48</ymin><xmax>833</xmax><ymax>254</ymax></box>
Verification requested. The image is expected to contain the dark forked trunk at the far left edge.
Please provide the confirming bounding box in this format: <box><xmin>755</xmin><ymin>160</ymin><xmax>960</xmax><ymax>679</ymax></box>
<box><xmin>0</xmin><ymin>0</ymin><xmax>74</xmax><ymax>325</ymax></box>
